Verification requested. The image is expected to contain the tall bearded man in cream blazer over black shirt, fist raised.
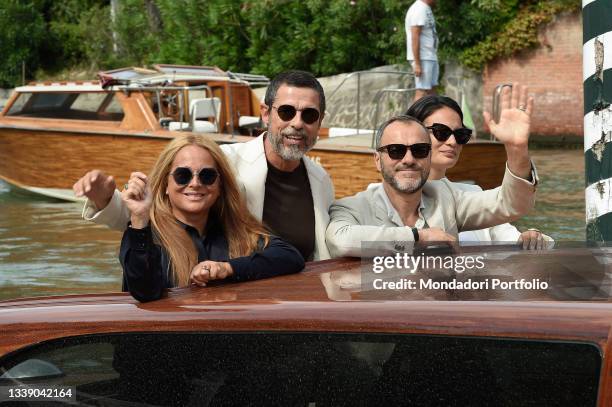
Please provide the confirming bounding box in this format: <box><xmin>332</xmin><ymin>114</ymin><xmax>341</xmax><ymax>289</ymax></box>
<box><xmin>73</xmin><ymin>71</ymin><xmax>334</xmax><ymax>260</ymax></box>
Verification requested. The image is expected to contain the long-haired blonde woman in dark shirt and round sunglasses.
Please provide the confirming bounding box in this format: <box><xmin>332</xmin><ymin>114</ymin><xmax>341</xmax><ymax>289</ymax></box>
<box><xmin>119</xmin><ymin>135</ymin><xmax>304</xmax><ymax>301</ymax></box>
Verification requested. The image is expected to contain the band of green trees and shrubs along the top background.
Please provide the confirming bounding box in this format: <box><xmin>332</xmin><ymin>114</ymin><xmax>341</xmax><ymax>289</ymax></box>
<box><xmin>0</xmin><ymin>0</ymin><xmax>580</xmax><ymax>85</ymax></box>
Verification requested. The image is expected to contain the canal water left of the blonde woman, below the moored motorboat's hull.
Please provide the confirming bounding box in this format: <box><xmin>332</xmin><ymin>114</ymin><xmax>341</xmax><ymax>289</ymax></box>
<box><xmin>0</xmin><ymin>181</ymin><xmax>121</xmax><ymax>299</ymax></box>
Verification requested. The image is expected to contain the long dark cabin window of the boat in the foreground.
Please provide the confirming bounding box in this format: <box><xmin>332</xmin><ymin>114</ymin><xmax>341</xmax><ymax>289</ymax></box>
<box><xmin>0</xmin><ymin>332</ymin><xmax>603</xmax><ymax>407</ymax></box>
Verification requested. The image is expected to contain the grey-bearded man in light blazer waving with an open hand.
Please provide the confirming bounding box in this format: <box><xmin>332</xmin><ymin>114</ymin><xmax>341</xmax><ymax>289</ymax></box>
<box><xmin>326</xmin><ymin>92</ymin><xmax>537</xmax><ymax>257</ymax></box>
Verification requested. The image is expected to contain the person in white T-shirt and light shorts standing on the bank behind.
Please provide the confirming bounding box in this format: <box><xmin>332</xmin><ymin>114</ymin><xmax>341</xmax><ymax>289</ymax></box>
<box><xmin>405</xmin><ymin>0</ymin><xmax>440</xmax><ymax>101</ymax></box>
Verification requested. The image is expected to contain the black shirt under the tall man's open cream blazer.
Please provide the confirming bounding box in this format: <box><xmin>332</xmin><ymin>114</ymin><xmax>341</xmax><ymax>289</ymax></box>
<box><xmin>263</xmin><ymin>160</ymin><xmax>315</xmax><ymax>260</ymax></box>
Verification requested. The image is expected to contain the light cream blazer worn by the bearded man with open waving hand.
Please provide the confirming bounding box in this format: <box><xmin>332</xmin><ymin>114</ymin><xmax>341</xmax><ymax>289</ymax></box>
<box><xmin>326</xmin><ymin>168</ymin><xmax>537</xmax><ymax>257</ymax></box>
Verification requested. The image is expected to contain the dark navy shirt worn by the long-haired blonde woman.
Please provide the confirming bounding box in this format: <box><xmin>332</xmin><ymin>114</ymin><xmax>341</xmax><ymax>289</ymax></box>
<box><xmin>119</xmin><ymin>224</ymin><xmax>304</xmax><ymax>302</ymax></box>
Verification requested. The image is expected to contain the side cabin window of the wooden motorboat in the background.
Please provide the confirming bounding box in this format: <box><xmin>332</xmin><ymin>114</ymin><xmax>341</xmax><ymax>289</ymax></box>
<box><xmin>7</xmin><ymin>92</ymin><xmax>124</xmax><ymax>121</ymax></box>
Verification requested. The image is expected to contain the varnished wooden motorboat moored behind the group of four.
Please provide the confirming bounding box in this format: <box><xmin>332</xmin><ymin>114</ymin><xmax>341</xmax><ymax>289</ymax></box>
<box><xmin>0</xmin><ymin>65</ymin><xmax>505</xmax><ymax>200</ymax></box>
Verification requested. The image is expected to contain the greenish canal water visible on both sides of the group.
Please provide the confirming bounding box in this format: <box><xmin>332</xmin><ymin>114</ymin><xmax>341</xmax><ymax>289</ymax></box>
<box><xmin>0</xmin><ymin>150</ymin><xmax>585</xmax><ymax>299</ymax></box>
